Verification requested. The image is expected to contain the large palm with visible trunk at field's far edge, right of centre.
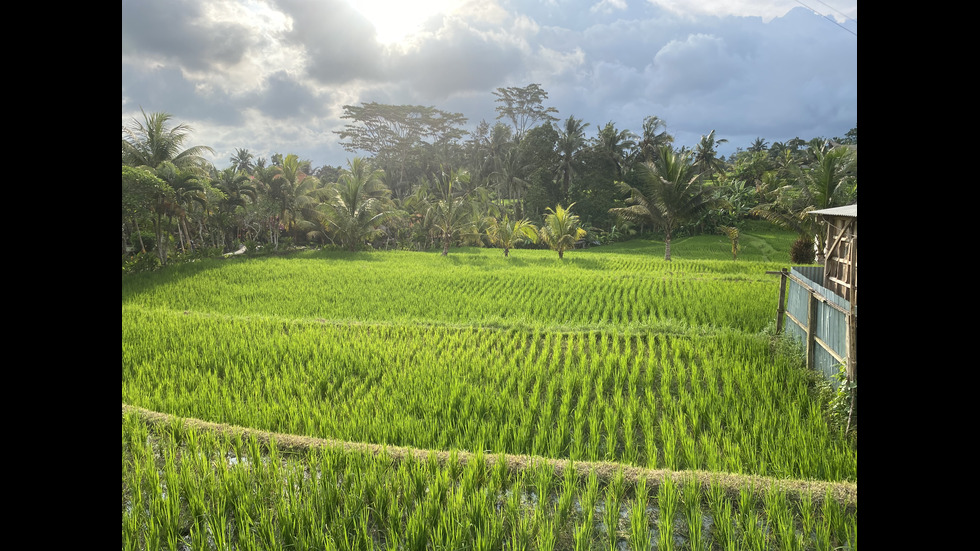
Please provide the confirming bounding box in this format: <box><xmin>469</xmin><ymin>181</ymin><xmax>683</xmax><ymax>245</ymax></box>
<box><xmin>610</xmin><ymin>146</ymin><xmax>714</xmax><ymax>261</ymax></box>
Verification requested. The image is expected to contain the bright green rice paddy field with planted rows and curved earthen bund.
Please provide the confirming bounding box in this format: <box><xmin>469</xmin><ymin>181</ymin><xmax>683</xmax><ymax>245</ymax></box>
<box><xmin>122</xmin><ymin>226</ymin><xmax>857</xmax><ymax>550</ymax></box>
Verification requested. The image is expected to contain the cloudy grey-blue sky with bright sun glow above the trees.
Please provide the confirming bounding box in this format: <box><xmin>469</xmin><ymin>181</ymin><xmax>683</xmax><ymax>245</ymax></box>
<box><xmin>122</xmin><ymin>0</ymin><xmax>857</xmax><ymax>169</ymax></box>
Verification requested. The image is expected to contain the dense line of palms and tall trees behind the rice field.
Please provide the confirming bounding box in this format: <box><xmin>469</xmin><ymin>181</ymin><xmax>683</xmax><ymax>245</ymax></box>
<box><xmin>122</xmin><ymin>84</ymin><xmax>857</xmax><ymax>267</ymax></box>
